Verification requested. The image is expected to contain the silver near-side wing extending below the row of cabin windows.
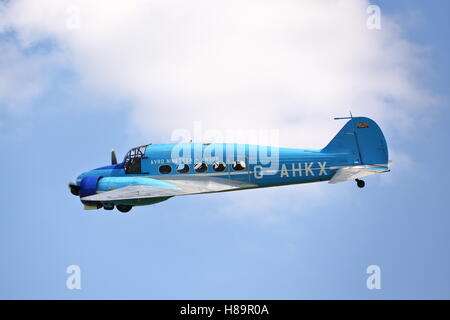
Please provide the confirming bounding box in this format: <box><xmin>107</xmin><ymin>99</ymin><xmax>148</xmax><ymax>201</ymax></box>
<box><xmin>81</xmin><ymin>177</ymin><xmax>255</xmax><ymax>201</ymax></box>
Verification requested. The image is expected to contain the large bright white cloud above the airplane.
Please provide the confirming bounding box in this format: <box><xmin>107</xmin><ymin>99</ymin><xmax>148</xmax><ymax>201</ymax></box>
<box><xmin>0</xmin><ymin>0</ymin><xmax>433</xmax><ymax>147</ymax></box>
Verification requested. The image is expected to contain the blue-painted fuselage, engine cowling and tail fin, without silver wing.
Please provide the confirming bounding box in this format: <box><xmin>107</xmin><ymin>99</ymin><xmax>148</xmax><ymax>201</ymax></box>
<box><xmin>73</xmin><ymin>117</ymin><xmax>388</xmax><ymax>205</ymax></box>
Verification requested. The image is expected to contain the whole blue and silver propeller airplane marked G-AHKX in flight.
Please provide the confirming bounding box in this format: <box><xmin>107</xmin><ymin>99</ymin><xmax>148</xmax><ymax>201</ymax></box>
<box><xmin>69</xmin><ymin>115</ymin><xmax>390</xmax><ymax>212</ymax></box>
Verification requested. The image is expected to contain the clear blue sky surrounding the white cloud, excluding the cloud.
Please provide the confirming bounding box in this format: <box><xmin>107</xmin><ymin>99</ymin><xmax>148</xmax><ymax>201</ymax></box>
<box><xmin>0</xmin><ymin>0</ymin><xmax>450</xmax><ymax>299</ymax></box>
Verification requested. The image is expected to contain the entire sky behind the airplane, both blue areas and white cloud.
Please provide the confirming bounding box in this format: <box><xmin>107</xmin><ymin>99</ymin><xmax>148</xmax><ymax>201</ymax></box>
<box><xmin>0</xmin><ymin>0</ymin><xmax>450</xmax><ymax>299</ymax></box>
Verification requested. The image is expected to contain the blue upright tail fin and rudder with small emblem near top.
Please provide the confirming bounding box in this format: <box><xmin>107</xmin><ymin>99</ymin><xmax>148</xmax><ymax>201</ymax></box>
<box><xmin>322</xmin><ymin>117</ymin><xmax>388</xmax><ymax>165</ymax></box>
